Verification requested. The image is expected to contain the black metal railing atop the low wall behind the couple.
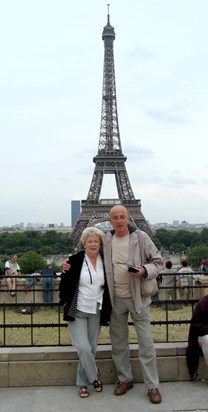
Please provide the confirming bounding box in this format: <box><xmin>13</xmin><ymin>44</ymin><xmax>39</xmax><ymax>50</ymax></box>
<box><xmin>0</xmin><ymin>271</ymin><xmax>208</xmax><ymax>347</ymax></box>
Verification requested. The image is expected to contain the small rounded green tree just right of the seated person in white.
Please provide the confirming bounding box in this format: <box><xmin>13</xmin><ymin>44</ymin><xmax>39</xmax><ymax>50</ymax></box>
<box><xmin>18</xmin><ymin>250</ymin><xmax>46</xmax><ymax>274</ymax></box>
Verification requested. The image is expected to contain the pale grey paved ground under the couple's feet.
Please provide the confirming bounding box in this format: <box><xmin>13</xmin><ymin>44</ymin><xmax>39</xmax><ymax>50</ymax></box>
<box><xmin>0</xmin><ymin>381</ymin><xmax>208</xmax><ymax>412</ymax></box>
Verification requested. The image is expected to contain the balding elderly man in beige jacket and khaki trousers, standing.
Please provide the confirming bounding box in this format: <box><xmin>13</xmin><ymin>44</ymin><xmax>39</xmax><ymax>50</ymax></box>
<box><xmin>103</xmin><ymin>205</ymin><xmax>163</xmax><ymax>403</ymax></box>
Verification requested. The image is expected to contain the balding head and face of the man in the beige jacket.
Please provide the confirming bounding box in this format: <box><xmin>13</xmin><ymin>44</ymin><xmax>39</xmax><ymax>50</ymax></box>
<box><xmin>109</xmin><ymin>206</ymin><xmax>129</xmax><ymax>236</ymax></box>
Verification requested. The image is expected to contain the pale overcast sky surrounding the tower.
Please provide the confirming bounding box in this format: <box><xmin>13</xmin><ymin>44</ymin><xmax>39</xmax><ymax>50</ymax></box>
<box><xmin>0</xmin><ymin>0</ymin><xmax>208</xmax><ymax>226</ymax></box>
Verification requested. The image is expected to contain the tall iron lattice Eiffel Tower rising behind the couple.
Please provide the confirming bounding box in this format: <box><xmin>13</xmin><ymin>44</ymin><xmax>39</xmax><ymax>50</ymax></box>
<box><xmin>70</xmin><ymin>5</ymin><xmax>152</xmax><ymax>247</ymax></box>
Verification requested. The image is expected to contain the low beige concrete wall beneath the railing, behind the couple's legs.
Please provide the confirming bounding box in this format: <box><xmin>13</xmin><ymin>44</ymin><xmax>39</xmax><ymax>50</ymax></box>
<box><xmin>0</xmin><ymin>343</ymin><xmax>208</xmax><ymax>387</ymax></box>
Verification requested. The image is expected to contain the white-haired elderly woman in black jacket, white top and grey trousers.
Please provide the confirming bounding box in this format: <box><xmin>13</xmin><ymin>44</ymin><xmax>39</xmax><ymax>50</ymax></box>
<box><xmin>59</xmin><ymin>227</ymin><xmax>111</xmax><ymax>398</ymax></box>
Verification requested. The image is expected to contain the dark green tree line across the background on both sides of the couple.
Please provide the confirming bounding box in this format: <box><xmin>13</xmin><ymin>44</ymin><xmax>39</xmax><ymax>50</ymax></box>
<box><xmin>0</xmin><ymin>228</ymin><xmax>208</xmax><ymax>273</ymax></box>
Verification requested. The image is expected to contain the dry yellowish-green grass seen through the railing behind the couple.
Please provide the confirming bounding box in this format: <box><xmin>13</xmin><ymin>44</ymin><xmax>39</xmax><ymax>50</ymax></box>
<box><xmin>0</xmin><ymin>305</ymin><xmax>192</xmax><ymax>346</ymax></box>
